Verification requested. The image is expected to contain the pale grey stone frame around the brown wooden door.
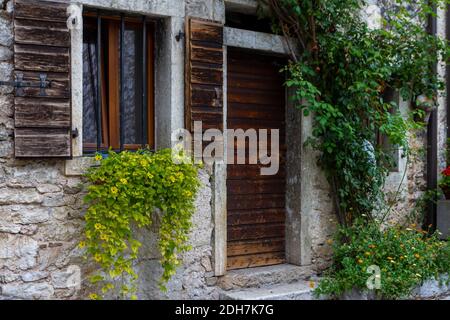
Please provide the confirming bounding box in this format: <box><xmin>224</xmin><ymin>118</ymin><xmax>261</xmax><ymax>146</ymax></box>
<box><xmin>211</xmin><ymin>27</ymin><xmax>312</xmax><ymax>276</ymax></box>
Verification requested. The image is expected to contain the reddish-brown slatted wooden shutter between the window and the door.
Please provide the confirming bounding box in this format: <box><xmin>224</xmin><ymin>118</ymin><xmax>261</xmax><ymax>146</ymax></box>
<box><xmin>185</xmin><ymin>18</ymin><xmax>223</xmax><ymax>131</ymax></box>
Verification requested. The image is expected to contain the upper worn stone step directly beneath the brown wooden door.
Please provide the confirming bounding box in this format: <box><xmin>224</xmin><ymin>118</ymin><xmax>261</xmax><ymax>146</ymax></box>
<box><xmin>218</xmin><ymin>264</ymin><xmax>314</xmax><ymax>291</ymax></box>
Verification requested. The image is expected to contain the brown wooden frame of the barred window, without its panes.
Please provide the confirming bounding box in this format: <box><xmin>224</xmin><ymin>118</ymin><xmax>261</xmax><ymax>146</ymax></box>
<box><xmin>82</xmin><ymin>12</ymin><xmax>156</xmax><ymax>155</ymax></box>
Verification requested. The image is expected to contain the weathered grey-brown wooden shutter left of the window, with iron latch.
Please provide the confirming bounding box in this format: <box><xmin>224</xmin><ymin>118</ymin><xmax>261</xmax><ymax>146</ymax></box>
<box><xmin>14</xmin><ymin>0</ymin><xmax>72</xmax><ymax>158</ymax></box>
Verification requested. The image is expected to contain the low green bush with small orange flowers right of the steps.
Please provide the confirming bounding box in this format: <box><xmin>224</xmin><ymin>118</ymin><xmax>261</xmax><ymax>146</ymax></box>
<box><xmin>314</xmin><ymin>222</ymin><xmax>450</xmax><ymax>299</ymax></box>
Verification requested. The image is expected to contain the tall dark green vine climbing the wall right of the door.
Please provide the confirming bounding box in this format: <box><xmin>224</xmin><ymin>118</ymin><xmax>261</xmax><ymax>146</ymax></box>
<box><xmin>260</xmin><ymin>0</ymin><xmax>448</xmax><ymax>226</ymax></box>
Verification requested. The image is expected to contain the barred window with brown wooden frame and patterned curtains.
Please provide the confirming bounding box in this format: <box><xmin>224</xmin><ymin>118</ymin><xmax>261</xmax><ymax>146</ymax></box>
<box><xmin>83</xmin><ymin>13</ymin><xmax>155</xmax><ymax>153</ymax></box>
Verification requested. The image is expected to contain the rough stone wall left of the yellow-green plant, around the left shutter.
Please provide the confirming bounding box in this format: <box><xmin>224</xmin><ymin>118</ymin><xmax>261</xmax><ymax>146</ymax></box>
<box><xmin>0</xmin><ymin>1</ymin><xmax>87</xmax><ymax>299</ymax></box>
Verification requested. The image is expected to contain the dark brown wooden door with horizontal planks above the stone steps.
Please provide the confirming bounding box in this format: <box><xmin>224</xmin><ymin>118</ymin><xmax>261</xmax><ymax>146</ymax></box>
<box><xmin>227</xmin><ymin>49</ymin><xmax>286</xmax><ymax>270</ymax></box>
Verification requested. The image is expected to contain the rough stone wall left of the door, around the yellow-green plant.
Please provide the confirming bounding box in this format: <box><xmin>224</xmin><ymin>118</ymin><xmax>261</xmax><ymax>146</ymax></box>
<box><xmin>0</xmin><ymin>1</ymin><xmax>218</xmax><ymax>299</ymax></box>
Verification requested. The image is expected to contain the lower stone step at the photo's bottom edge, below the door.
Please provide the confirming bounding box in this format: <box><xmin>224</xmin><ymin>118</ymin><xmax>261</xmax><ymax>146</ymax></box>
<box><xmin>220</xmin><ymin>281</ymin><xmax>314</xmax><ymax>300</ymax></box>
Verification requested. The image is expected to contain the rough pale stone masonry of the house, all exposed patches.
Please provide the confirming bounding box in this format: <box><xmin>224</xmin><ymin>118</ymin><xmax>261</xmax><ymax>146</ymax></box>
<box><xmin>0</xmin><ymin>0</ymin><xmax>446</xmax><ymax>299</ymax></box>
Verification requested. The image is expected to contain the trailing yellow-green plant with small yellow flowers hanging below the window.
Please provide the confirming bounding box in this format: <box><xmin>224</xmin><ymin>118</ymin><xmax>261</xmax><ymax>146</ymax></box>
<box><xmin>80</xmin><ymin>149</ymin><xmax>200</xmax><ymax>298</ymax></box>
